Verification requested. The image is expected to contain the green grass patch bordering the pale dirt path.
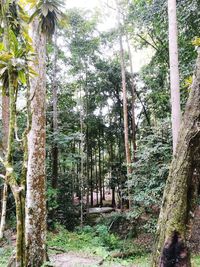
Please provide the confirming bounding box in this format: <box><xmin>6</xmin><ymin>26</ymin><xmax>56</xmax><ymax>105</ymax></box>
<box><xmin>48</xmin><ymin>226</ymin><xmax>149</xmax><ymax>267</ymax></box>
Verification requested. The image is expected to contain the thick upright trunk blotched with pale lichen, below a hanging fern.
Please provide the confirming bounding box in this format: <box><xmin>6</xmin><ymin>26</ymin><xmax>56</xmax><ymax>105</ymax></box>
<box><xmin>25</xmin><ymin>19</ymin><xmax>46</xmax><ymax>267</ymax></box>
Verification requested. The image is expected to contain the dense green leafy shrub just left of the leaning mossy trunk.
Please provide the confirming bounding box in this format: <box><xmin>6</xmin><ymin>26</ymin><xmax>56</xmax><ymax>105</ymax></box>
<box><xmin>130</xmin><ymin>121</ymin><xmax>171</xmax><ymax>211</ymax></box>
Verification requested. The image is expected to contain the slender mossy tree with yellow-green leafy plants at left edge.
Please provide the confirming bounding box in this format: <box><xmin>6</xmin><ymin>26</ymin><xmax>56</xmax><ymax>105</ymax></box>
<box><xmin>0</xmin><ymin>1</ymin><xmax>30</xmax><ymax>266</ymax></box>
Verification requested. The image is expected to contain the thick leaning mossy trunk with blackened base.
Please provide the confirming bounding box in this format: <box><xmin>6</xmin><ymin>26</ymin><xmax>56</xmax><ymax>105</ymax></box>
<box><xmin>152</xmin><ymin>51</ymin><xmax>200</xmax><ymax>267</ymax></box>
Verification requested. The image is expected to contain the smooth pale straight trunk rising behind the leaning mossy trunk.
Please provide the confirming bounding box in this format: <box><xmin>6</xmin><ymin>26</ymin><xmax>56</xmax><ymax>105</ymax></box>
<box><xmin>168</xmin><ymin>0</ymin><xmax>181</xmax><ymax>154</ymax></box>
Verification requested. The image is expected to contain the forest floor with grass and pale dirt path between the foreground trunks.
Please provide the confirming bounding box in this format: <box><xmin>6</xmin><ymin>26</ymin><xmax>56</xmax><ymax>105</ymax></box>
<box><xmin>0</xmin><ymin>226</ymin><xmax>200</xmax><ymax>267</ymax></box>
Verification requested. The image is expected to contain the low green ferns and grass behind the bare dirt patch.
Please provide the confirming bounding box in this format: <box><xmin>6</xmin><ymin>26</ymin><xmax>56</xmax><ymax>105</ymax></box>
<box><xmin>48</xmin><ymin>224</ymin><xmax>150</xmax><ymax>263</ymax></box>
